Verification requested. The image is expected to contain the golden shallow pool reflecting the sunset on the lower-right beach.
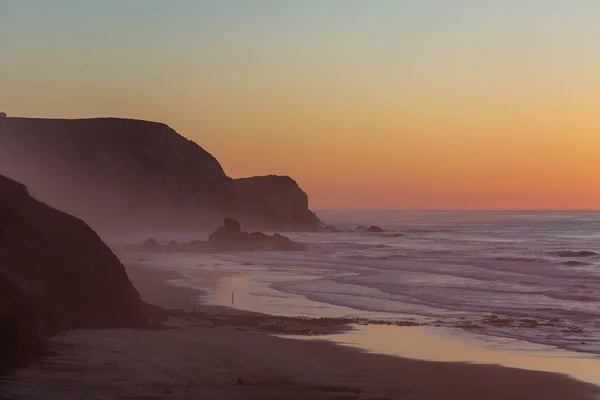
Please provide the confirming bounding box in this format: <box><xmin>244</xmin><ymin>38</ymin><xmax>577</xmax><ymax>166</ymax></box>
<box><xmin>296</xmin><ymin>325</ymin><xmax>600</xmax><ymax>385</ymax></box>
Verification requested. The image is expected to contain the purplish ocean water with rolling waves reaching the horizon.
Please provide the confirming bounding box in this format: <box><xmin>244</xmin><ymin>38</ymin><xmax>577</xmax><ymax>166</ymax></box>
<box><xmin>132</xmin><ymin>211</ymin><xmax>600</xmax><ymax>354</ymax></box>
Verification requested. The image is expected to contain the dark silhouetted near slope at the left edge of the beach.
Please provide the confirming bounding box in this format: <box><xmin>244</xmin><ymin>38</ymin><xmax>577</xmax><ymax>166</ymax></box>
<box><xmin>0</xmin><ymin>176</ymin><xmax>145</xmax><ymax>369</ymax></box>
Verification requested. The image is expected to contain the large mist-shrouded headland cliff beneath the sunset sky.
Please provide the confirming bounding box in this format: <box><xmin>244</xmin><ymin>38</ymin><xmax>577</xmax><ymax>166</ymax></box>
<box><xmin>0</xmin><ymin>118</ymin><xmax>319</xmax><ymax>230</ymax></box>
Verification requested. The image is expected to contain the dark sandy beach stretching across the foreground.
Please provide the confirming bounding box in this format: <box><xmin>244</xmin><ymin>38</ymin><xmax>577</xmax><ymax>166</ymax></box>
<box><xmin>0</xmin><ymin>267</ymin><xmax>600</xmax><ymax>400</ymax></box>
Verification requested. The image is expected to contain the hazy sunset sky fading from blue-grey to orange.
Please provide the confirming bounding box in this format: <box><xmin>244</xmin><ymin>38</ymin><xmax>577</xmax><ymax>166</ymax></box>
<box><xmin>0</xmin><ymin>0</ymin><xmax>600</xmax><ymax>210</ymax></box>
